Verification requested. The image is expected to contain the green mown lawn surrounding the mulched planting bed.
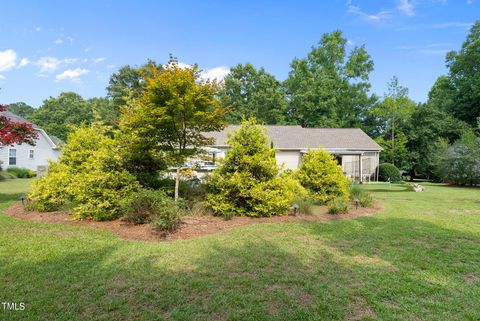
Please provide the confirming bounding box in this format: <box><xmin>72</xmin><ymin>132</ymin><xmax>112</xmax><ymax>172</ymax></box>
<box><xmin>0</xmin><ymin>180</ymin><xmax>480</xmax><ymax>320</ymax></box>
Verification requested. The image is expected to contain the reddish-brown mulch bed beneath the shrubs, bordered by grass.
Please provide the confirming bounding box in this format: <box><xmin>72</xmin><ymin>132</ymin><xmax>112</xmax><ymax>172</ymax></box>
<box><xmin>5</xmin><ymin>202</ymin><xmax>383</xmax><ymax>242</ymax></box>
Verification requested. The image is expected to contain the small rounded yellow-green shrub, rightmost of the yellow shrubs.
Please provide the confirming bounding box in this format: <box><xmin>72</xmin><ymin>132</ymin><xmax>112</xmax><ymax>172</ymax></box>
<box><xmin>297</xmin><ymin>150</ymin><xmax>350</xmax><ymax>204</ymax></box>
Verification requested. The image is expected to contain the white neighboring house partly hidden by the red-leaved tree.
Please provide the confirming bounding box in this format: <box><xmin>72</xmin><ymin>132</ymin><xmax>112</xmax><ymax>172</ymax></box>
<box><xmin>0</xmin><ymin>111</ymin><xmax>62</xmax><ymax>172</ymax></box>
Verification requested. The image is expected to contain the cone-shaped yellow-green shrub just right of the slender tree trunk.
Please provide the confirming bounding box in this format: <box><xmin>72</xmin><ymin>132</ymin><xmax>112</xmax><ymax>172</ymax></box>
<box><xmin>205</xmin><ymin>119</ymin><xmax>299</xmax><ymax>218</ymax></box>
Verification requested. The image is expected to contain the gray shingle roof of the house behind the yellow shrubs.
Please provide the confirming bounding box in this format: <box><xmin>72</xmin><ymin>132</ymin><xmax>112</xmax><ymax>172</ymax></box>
<box><xmin>205</xmin><ymin>125</ymin><xmax>382</xmax><ymax>150</ymax></box>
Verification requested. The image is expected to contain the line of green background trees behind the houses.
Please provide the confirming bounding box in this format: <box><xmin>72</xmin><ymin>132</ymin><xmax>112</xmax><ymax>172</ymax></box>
<box><xmin>10</xmin><ymin>21</ymin><xmax>480</xmax><ymax>184</ymax></box>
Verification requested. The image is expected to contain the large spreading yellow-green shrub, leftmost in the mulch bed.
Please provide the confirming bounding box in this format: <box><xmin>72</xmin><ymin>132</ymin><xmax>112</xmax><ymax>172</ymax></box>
<box><xmin>28</xmin><ymin>125</ymin><xmax>138</xmax><ymax>220</ymax></box>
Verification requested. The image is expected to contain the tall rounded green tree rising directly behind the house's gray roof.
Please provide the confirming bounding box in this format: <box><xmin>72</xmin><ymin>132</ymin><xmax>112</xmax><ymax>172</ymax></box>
<box><xmin>285</xmin><ymin>30</ymin><xmax>373</xmax><ymax>127</ymax></box>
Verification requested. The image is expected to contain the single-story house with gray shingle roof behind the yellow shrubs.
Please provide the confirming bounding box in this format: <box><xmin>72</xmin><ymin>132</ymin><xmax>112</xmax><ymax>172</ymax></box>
<box><xmin>205</xmin><ymin>125</ymin><xmax>382</xmax><ymax>181</ymax></box>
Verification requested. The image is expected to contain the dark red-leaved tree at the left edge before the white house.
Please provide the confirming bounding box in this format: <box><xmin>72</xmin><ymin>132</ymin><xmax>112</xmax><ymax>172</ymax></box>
<box><xmin>0</xmin><ymin>104</ymin><xmax>38</xmax><ymax>146</ymax></box>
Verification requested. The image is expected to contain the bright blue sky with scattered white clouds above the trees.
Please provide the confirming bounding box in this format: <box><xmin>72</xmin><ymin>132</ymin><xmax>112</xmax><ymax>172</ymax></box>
<box><xmin>0</xmin><ymin>0</ymin><xmax>480</xmax><ymax>107</ymax></box>
